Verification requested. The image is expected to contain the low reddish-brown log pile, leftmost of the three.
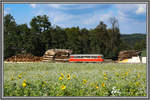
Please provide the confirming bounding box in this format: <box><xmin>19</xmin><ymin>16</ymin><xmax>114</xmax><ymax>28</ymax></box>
<box><xmin>5</xmin><ymin>54</ymin><xmax>43</xmax><ymax>62</ymax></box>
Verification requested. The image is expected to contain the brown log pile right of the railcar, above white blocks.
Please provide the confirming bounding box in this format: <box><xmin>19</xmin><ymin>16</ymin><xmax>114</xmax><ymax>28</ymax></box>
<box><xmin>118</xmin><ymin>50</ymin><xmax>142</xmax><ymax>61</ymax></box>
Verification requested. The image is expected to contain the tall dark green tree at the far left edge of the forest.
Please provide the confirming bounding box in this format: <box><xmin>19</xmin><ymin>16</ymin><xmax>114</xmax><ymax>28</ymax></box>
<box><xmin>4</xmin><ymin>14</ymin><xmax>17</xmax><ymax>59</ymax></box>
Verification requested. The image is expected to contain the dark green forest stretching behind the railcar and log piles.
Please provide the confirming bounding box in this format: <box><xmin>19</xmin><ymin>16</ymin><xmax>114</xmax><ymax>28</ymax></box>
<box><xmin>4</xmin><ymin>14</ymin><xmax>146</xmax><ymax>59</ymax></box>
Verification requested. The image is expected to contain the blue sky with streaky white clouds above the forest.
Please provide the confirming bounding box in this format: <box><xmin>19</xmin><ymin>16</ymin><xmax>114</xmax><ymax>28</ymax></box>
<box><xmin>4</xmin><ymin>4</ymin><xmax>146</xmax><ymax>34</ymax></box>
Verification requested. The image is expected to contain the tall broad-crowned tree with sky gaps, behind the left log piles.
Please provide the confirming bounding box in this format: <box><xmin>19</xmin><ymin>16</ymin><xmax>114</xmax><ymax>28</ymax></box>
<box><xmin>29</xmin><ymin>15</ymin><xmax>52</xmax><ymax>56</ymax></box>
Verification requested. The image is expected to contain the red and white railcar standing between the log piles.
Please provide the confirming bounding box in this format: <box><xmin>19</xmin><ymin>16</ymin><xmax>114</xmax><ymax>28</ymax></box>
<box><xmin>69</xmin><ymin>54</ymin><xmax>104</xmax><ymax>62</ymax></box>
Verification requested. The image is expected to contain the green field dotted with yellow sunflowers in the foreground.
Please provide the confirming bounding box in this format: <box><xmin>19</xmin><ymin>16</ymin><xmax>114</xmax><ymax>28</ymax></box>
<box><xmin>4</xmin><ymin>62</ymin><xmax>146</xmax><ymax>96</ymax></box>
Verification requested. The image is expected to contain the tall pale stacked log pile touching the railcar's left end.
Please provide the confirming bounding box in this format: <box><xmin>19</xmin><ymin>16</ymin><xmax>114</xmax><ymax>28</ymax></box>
<box><xmin>42</xmin><ymin>49</ymin><xmax>72</xmax><ymax>62</ymax></box>
